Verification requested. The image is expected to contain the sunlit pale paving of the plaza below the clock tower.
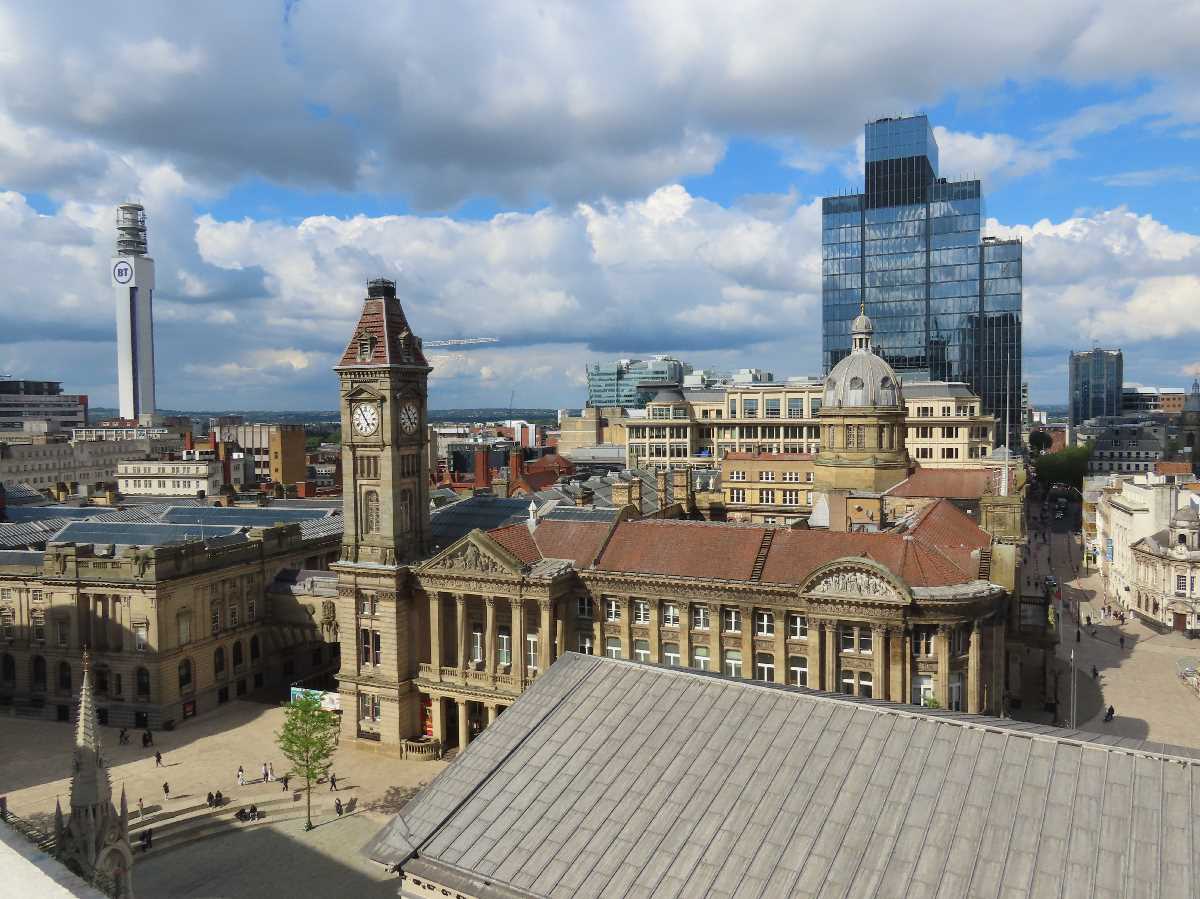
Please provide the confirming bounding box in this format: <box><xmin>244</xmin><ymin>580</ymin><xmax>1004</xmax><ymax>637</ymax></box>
<box><xmin>0</xmin><ymin>701</ymin><xmax>446</xmax><ymax>844</ymax></box>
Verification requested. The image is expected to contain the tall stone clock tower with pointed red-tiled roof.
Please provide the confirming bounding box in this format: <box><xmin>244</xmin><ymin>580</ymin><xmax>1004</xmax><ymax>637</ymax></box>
<box><xmin>332</xmin><ymin>278</ymin><xmax>431</xmax><ymax>754</ymax></box>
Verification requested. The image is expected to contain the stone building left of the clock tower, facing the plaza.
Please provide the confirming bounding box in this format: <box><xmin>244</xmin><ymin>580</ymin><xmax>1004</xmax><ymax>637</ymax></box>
<box><xmin>0</xmin><ymin>525</ymin><xmax>338</xmax><ymax>729</ymax></box>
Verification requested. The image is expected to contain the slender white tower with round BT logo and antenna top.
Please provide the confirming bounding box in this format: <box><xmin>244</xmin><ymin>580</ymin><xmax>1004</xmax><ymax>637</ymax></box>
<box><xmin>112</xmin><ymin>203</ymin><xmax>155</xmax><ymax>419</ymax></box>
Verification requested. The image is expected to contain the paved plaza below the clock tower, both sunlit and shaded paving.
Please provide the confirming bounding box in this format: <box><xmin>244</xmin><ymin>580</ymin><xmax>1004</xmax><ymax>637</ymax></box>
<box><xmin>0</xmin><ymin>702</ymin><xmax>446</xmax><ymax>898</ymax></box>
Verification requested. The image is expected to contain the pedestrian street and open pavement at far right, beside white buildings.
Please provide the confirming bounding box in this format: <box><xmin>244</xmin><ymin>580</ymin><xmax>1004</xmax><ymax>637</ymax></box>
<box><xmin>1030</xmin><ymin>494</ymin><xmax>1200</xmax><ymax>747</ymax></box>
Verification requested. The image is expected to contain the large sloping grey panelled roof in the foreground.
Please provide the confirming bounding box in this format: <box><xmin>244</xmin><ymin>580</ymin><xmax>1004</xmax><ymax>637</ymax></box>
<box><xmin>365</xmin><ymin>653</ymin><xmax>1200</xmax><ymax>899</ymax></box>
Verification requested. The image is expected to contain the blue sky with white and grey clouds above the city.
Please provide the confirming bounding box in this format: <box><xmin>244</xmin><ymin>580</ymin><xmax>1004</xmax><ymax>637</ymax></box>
<box><xmin>0</xmin><ymin>0</ymin><xmax>1200</xmax><ymax>409</ymax></box>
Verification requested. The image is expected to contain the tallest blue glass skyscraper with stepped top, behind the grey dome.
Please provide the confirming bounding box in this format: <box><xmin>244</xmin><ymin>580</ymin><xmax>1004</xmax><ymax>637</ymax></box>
<box><xmin>821</xmin><ymin>115</ymin><xmax>1021</xmax><ymax>446</ymax></box>
